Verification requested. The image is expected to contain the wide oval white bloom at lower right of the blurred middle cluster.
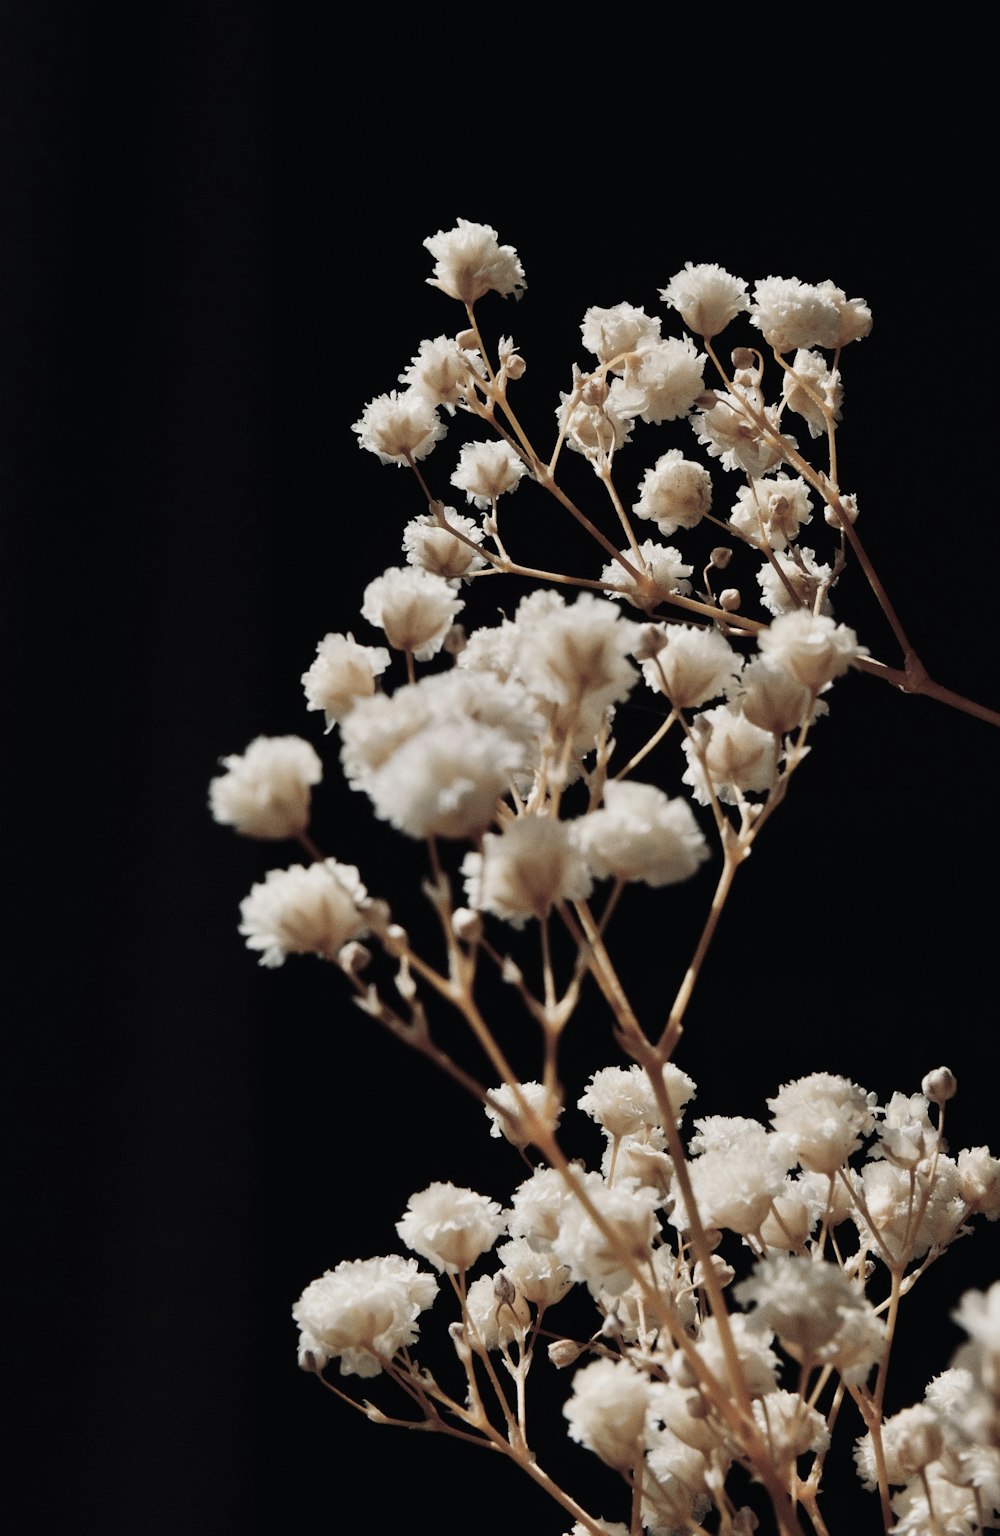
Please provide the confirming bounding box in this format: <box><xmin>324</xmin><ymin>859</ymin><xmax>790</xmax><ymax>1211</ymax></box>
<box><xmin>579</xmin><ymin>780</ymin><xmax>708</xmax><ymax>886</ymax></box>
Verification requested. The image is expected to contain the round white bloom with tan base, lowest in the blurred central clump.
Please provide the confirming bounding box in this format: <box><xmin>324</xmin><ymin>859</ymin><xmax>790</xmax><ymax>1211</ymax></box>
<box><xmin>462</xmin><ymin>816</ymin><xmax>591</xmax><ymax>928</ymax></box>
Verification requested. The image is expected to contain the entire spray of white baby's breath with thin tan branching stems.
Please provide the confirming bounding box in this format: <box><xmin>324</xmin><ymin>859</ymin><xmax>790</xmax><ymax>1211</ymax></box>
<box><xmin>210</xmin><ymin>220</ymin><xmax>1000</xmax><ymax>1536</ymax></box>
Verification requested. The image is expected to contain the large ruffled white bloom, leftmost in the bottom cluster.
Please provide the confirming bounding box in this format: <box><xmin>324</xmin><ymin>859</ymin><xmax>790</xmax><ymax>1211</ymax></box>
<box><xmin>292</xmin><ymin>1253</ymin><xmax>438</xmax><ymax>1376</ymax></box>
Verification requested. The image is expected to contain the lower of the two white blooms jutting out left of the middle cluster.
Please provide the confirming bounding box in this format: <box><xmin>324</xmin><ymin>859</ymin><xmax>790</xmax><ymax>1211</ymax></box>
<box><xmin>240</xmin><ymin>859</ymin><xmax>367</xmax><ymax>966</ymax></box>
